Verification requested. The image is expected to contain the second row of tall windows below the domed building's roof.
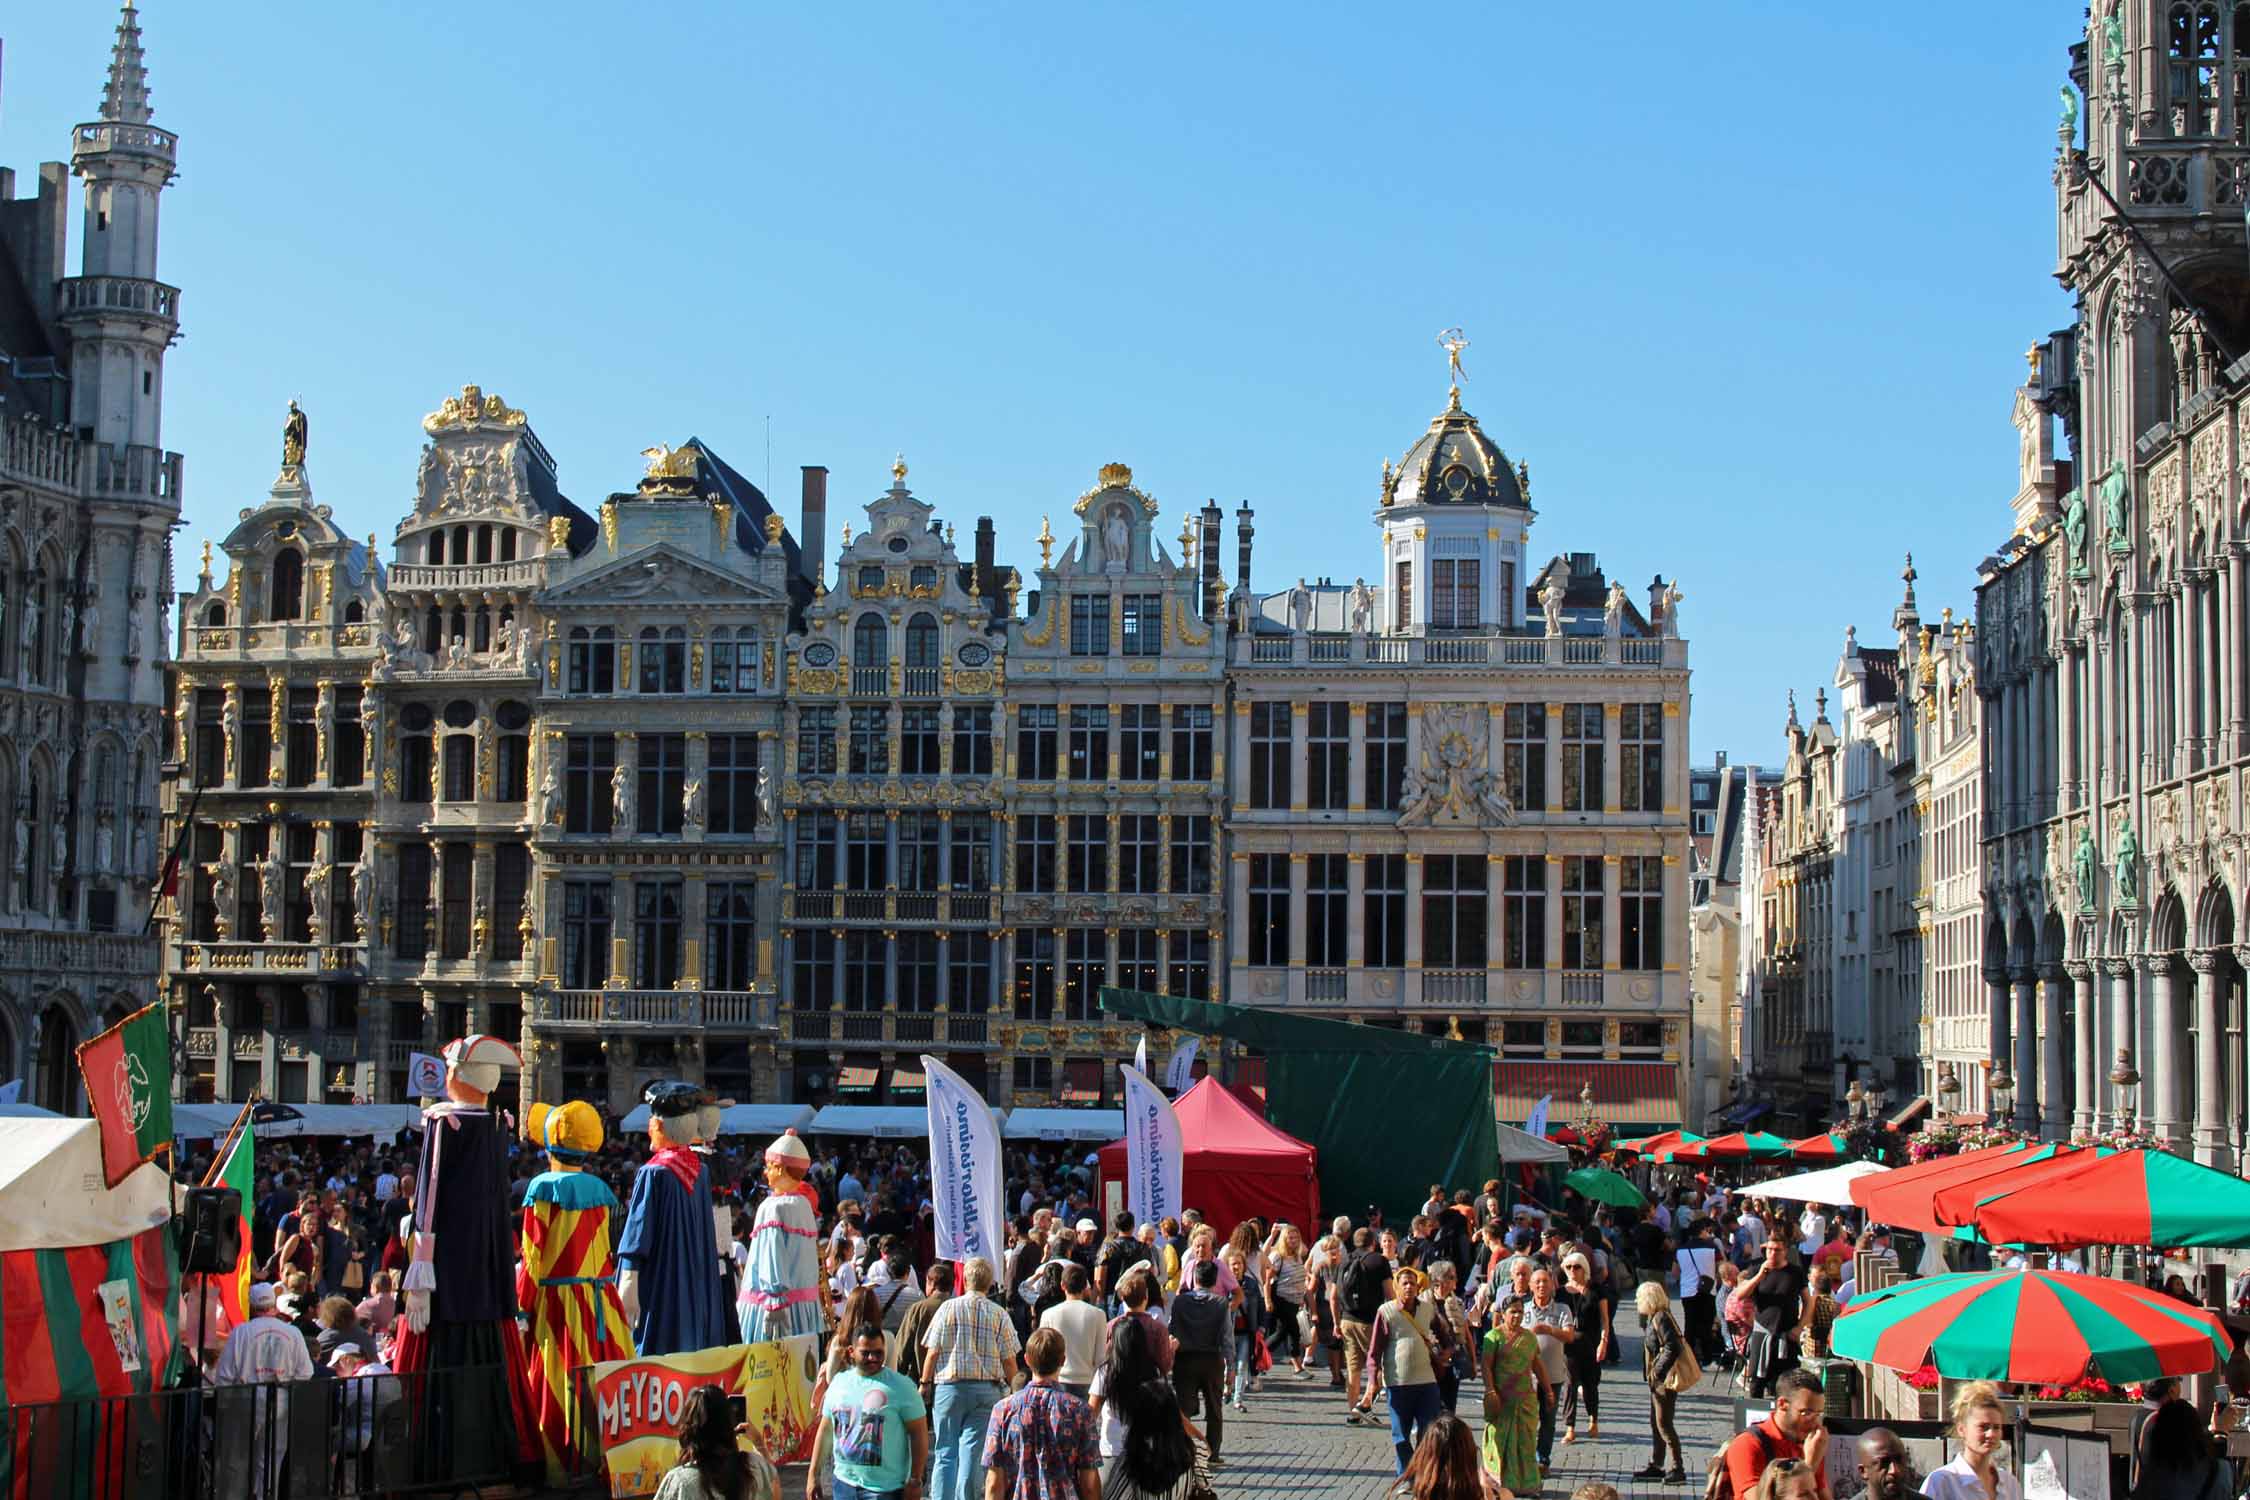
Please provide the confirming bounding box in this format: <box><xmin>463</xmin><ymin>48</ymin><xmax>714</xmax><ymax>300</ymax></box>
<box><xmin>1247</xmin><ymin>855</ymin><xmax>1665</xmax><ymax>969</ymax></box>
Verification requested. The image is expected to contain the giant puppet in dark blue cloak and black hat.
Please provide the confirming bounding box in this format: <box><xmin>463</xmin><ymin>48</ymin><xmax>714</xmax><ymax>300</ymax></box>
<box><xmin>617</xmin><ymin>1082</ymin><xmax>734</xmax><ymax>1358</ymax></box>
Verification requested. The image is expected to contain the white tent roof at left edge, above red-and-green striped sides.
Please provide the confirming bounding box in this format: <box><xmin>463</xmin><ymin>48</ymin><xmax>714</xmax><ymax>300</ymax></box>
<box><xmin>0</xmin><ymin>1118</ymin><xmax>171</xmax><ymax>1250</ymax></box>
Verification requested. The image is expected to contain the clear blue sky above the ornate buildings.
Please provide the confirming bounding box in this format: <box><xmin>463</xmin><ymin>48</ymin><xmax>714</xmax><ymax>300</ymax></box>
<box><xmin>0</xmin><ymin>0</ymin><xmax>2084</xmax><ymax>762</ymax></box>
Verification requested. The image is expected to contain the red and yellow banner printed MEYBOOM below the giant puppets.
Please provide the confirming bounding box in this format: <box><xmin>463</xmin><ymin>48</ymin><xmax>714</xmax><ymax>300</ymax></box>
<box><xmin>590</xmin><ymin>1334</ymin><xmax>819</xmax><ymax>1496</ymax></box>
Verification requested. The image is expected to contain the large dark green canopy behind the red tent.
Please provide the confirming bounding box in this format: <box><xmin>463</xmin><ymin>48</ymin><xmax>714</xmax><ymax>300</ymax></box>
<box><xmin>1100</xmin><ymin>987</ymin><xmax>1501</xmax><ymax>1223</ymax></box>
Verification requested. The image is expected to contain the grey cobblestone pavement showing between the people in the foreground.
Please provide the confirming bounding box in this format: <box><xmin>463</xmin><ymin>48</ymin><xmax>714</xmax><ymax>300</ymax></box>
<box><xmin>1215</xmin><ymin>1311</ymin><xmax>1733</xmax><ymax>1500</ymax></box>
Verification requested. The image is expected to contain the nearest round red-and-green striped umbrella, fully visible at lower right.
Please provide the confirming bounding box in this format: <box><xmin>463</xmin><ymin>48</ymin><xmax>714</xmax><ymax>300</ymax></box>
<box><xmin>1832</xmin><ymin>1271</ymin><xmax>2234</xmax><ymax>1385</ymax></box>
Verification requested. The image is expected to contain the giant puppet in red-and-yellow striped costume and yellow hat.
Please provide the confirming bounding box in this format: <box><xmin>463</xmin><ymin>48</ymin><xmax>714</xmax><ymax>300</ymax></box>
<box><xmin>515</xmin><ymin>1100</ymin><xmax>632</xmax><ymax>1487</ymax></box>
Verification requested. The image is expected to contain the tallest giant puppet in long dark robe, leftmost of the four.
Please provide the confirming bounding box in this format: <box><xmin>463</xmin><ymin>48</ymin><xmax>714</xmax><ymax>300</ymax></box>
<box><xmin>392</xmin><ymin>1034</ymin><xmax>538</xmax><ymax>1478</ymax></box>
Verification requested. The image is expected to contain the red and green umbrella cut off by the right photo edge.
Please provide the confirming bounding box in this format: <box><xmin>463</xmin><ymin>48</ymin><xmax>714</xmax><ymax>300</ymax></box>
<box><xmin>1935</xmin><ymin>1147</ymin><xmax>2250</xmax><ymax>1248</ymax></box>
